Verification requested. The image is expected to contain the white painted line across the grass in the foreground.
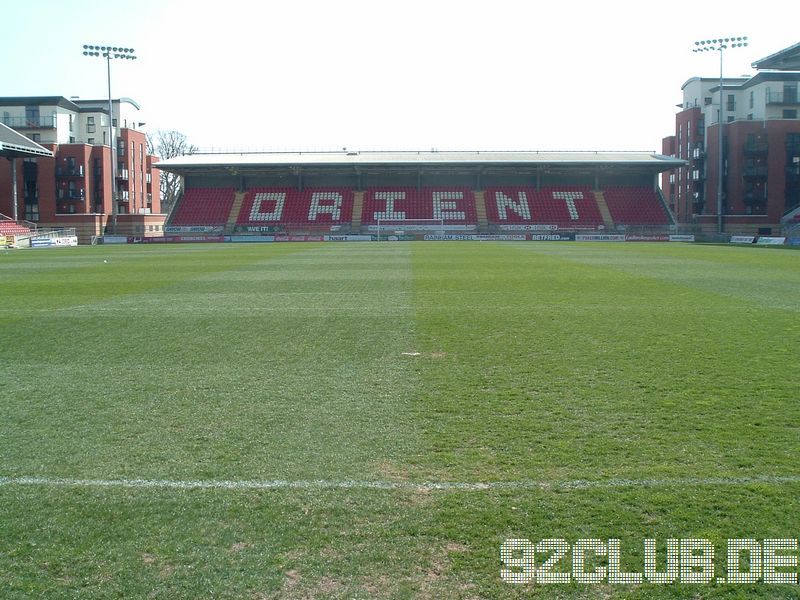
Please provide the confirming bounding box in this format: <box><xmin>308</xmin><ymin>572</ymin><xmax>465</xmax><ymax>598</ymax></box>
<box><xmin>0</xmin><ymin>475</ymin><xmax>800</xmax><ymax>492</ymax></box>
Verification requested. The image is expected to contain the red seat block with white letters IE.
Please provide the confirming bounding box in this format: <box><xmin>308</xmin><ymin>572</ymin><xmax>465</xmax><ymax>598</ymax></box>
<box><xmin>361</xmin><ymin>187</ymin><xmax>478</xmax><ymax>226</ymax></box>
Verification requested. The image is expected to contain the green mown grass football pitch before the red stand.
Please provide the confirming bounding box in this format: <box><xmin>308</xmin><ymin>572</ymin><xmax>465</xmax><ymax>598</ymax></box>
<box><xmin>0</xmin><ymin>242</ymin><xmax>800</xmax><ymax>598</ymax></box>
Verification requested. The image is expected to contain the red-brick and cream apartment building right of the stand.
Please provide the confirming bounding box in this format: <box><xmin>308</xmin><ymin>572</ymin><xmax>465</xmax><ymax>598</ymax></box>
<box><xmin>662</xmin><ymin>44</ymin><xmax>800</xmax><ymax>234</ymax></box>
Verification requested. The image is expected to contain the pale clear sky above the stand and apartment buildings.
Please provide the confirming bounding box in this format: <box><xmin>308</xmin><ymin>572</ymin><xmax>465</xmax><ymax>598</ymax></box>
<box><xmin>0</xmin><ymin>0</ymin><xmax>800</xmax><ymax>155</ymax></box>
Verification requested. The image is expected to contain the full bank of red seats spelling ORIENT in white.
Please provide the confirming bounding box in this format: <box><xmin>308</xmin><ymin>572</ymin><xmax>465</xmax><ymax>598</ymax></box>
<box><xmin>167</xmin><ymin>185</ymin><xmax>670</xmax><ymax>234</ymax></box>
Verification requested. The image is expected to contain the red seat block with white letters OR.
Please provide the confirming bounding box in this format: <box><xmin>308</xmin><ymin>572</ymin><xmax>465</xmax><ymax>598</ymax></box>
<box><xmin>236</xmin><ymin>187</ymin><xmax>353</xmax><ymax>230</ymax></box>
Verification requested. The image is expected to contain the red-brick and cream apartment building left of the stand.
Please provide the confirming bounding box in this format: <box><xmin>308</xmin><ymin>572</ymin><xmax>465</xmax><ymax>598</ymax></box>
<box><xmin>0</xmin><ymin>96</ymin><xmax>164</xmax><ymax>235</ymax></box>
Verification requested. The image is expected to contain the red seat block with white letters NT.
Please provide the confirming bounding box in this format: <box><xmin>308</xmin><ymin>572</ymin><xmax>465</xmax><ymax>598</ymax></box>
<box><xmin>484</xmin><ymin>186</ymin><xmax>603</xmax><ymax>229</ymax></box>
